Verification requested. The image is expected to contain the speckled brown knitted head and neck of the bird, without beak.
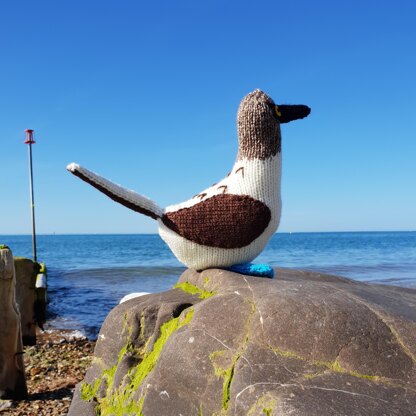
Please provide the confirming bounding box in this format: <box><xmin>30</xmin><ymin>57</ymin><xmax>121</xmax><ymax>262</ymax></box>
<box><xmin>237</xmin><ymin>90</ymin><xmax>281</xmax><ymax>160</ymax></box>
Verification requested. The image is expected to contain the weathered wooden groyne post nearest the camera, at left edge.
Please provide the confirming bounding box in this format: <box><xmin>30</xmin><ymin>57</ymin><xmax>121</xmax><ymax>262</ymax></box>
<box><xmin>0</xmin><ymin>246</ymin><xmax>27</xmax><ymax>399</ymax></box>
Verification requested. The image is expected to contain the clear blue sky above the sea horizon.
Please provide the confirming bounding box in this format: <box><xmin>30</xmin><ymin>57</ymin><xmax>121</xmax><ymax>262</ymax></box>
<box><xmin>0</xmin><ymin>0</ymin><xmax>416</xmax><ymax>234</ymax></box>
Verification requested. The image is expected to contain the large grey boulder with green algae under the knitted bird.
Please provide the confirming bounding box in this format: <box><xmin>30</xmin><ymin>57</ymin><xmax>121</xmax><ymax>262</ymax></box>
<box><xmin>69</xmin><ymin>269</ymin><xmax>416</xmax><ymax>416</ymax></box>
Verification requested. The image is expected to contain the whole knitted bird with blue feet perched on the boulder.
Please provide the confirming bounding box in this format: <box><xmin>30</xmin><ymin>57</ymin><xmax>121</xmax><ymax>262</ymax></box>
<box><xmin>67</xmin><ymin>90</ymin><xmax>310</xmax><ymax>275</ymax></box>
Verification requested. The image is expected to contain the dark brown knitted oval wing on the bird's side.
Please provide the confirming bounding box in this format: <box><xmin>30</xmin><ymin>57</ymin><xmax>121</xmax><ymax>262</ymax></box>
<box><xmin>162</xmin><ymin>194</ymin><xmax>271</xmax><ymax>248</ymax></box>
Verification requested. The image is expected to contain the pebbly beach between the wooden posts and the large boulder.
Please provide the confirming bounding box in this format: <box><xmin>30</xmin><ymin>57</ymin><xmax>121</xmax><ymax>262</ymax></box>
<box><xmin>0</xmin><ymin>330</ymin><xmax>95</xmax><ymax>416</ymax></box>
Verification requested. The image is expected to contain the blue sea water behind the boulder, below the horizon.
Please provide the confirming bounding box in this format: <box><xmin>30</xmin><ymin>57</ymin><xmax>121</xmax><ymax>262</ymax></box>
<box><xmin>0</xmin><ymin>232</ymin><xmax>416</xmax><ymax>338</ymax></box>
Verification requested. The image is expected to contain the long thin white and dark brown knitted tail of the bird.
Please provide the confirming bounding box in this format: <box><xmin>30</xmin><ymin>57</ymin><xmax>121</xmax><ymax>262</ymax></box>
<box><xmin>66</xmin><ymin>163</ymin><xmax>163</xmax><ymax>220</ymax></box>
